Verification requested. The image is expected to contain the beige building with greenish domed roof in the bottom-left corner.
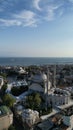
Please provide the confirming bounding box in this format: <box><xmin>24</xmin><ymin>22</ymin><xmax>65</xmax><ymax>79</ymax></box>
<box><xmin>0</xmin><ymin>106</ymin><xmax>13</xmax><ymax>130</ymax></box>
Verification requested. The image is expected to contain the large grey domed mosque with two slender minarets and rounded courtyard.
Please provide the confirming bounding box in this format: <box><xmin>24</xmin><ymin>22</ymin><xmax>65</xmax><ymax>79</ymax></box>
<box><xmin>29</xmin><ymin>69</ymin><xmax>70</xmax><ymax>106</ymax></box>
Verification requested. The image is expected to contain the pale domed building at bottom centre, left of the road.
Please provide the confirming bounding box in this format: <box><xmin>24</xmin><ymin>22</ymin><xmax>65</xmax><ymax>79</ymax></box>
<box><xmin>14</xmin><ymin>104</ymin><xmax>39</xmax><ymax>127</ymax></box>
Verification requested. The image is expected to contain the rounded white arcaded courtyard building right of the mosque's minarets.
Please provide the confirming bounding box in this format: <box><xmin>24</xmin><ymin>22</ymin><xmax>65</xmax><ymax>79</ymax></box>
<box><xmin>47</xmin><ymin>88</ymin><xmax>70</xmax><ymax>106</ymax></box>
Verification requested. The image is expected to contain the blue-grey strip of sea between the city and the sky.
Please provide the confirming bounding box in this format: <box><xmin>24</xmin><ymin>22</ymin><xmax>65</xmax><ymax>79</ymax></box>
<box><xmin>0</xmin><ymin>57</ymin><xmax>73</xmax><ymax>66</ymax></box>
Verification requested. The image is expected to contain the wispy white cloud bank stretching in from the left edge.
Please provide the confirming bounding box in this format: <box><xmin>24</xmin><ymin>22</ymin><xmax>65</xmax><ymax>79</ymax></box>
<box><xmin>0</xmin><ymin>10</ymin><xmax>37</xmax><ymax>27</ymax></box>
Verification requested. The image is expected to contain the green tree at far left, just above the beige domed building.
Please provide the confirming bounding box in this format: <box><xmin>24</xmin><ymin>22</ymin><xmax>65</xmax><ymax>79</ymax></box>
<box><xmin>3</xmin><ymin>94</ymin><xmax>15</xmax><ymax>107</ymax></box>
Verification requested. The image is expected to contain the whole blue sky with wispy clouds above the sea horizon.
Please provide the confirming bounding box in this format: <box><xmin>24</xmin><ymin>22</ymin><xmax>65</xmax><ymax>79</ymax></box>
<box><xmin>0</xmin><ymin>0</ymin><xmax>73</xmax><ymax>57</ymax></box>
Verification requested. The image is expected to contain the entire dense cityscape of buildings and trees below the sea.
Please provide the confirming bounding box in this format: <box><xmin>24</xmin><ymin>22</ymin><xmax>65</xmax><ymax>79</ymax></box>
<box><xmin>0</xmin><ymin>64</ymin><xmax>73</xmax><ymax>130</ymax></box>
